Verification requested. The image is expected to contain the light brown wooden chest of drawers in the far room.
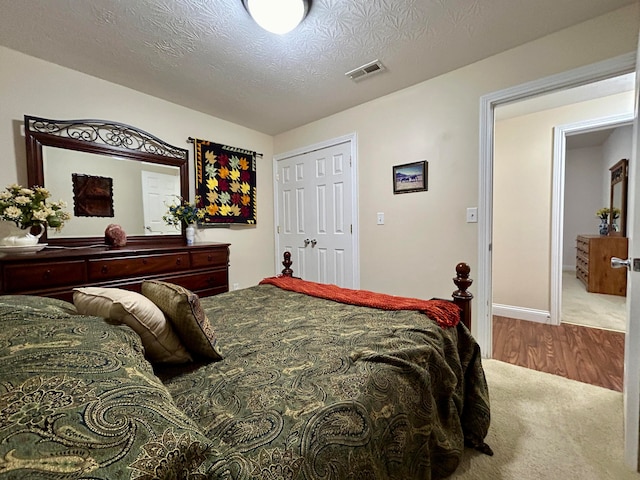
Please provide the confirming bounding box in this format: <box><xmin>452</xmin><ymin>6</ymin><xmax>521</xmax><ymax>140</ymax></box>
<box><xmin>576</xmin><ymin>235</ymin><xmax>628</xmax><ymax>296</ymax></box>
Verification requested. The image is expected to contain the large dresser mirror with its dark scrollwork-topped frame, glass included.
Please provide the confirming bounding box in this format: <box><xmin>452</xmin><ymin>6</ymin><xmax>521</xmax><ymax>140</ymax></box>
<box><xmin>24</xmin><ymin>116</ymin><xmax>189</xmax><ymax>246</ymax></box>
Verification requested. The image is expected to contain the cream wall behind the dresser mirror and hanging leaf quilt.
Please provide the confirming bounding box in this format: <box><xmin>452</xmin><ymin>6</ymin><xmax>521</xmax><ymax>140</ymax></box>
<box><xmin>0</xmin><ymin>47</ymin><xmax>274</xmax><ymax>288</ymax></box>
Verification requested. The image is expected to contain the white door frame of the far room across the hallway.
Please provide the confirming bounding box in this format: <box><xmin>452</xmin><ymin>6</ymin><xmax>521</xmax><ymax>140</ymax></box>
<box><xmin>549</xmin><ymin>112</ymin><xmax>634</xmax><ymax>325</ymax></box>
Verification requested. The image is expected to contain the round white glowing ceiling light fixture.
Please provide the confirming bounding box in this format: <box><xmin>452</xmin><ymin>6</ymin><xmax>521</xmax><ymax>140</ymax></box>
<box><xmin>242</xmin><ymin>0</ymin><xmax>310</xmax><ymax>35</ymax></box>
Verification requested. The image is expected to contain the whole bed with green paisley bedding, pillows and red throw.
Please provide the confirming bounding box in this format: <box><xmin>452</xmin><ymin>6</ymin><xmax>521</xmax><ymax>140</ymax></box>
<box><xmin>0</xmin><ymin>258</ymin><xmax>491</xmax><ymax>480</ymax></box>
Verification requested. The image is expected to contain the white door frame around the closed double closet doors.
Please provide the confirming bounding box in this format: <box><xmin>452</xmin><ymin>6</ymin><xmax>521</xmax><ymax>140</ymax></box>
<box><xmin>273</xmin><ymin>132</ymin><xmax>360</xmax><ymax>289</ymax></box>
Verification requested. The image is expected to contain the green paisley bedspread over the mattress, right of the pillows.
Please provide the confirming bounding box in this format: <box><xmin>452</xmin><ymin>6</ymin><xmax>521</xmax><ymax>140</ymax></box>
<box><xmin>160</xmin><ymin>285</ymin><xmax>489</xmax><ymax>480</ymax></box>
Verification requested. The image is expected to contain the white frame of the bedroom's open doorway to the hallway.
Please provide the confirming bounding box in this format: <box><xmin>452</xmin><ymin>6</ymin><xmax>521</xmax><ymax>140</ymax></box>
<box><xmin>474</xmin><ymin>52</ymin><xmax>636</xmax><ymax>358</ymax></box>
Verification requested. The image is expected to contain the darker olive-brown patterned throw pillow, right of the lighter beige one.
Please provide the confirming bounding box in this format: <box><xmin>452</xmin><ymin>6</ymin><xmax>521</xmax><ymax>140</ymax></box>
<box><xmin>142</xmin><ymin>280</ymin><xmax>222</xmax><ymax>360</ymax></box>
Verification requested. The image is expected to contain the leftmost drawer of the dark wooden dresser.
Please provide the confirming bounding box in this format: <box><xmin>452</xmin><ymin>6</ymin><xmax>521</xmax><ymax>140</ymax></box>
<box><xmin>4</xmin><ymin>260</ymin><xmax>87</xmax><ymax>292</ymax></box>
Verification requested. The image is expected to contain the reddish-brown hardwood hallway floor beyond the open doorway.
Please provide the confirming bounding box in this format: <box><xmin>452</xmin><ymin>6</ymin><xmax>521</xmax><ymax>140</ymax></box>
<box><xmin>493</xmin><ymin>316</ymin><xmax>624</xmax><ymax>392</ymax></box>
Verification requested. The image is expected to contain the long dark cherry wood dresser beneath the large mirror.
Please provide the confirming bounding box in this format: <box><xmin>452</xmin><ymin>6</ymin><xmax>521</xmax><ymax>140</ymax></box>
<box><xmin>0</xmin><ymin>243</ymin><xmax>229</xmax><ymax>301</ymax></box>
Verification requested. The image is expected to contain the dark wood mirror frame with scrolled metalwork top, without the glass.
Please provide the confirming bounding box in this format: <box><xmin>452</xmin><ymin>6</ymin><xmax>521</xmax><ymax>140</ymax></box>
<box><xmin>24</xmin><ymin>115</ymin><xmax>189</xmax><ymax>246</ymax></box>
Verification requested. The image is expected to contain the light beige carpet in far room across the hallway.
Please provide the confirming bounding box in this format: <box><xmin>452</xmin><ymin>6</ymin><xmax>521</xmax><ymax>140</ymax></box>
<box><xmin>560</xmin><ymin>272</ymin><xmax>627</xmax><ymax>332</ymax></box>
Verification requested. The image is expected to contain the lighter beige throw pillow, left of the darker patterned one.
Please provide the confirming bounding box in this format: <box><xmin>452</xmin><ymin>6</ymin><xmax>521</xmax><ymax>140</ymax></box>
<box><xmin>73</xmin><ymin>287</ymin><xmax>193</xmax><ymax>363</ymax></box>
